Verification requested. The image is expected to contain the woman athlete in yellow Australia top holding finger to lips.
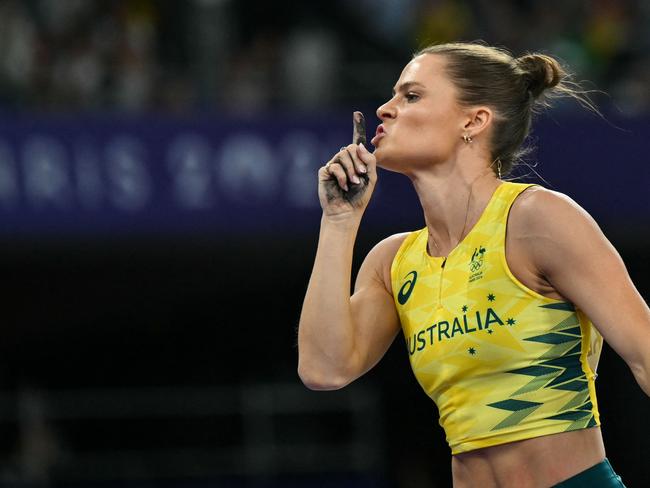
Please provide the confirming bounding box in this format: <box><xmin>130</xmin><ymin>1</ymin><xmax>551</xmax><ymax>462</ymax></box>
<box><xmin>298</xmin><ymin>43</ymin><xmax>650</xmax><ymax>488</ymax></box>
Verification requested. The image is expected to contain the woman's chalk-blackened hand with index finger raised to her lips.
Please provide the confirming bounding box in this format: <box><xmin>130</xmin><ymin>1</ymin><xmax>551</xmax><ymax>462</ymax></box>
<box><xmin>318</xmin><ymin>112</ymin><xmax>377</xmax><ymax>217</ymax></box>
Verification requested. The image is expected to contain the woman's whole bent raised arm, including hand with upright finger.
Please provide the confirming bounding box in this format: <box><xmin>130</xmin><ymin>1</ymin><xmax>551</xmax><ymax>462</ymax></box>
<box><xmin>298</xmin><ymin>112</ymin><xmax>403</xmax><ymax>390</ymax></box>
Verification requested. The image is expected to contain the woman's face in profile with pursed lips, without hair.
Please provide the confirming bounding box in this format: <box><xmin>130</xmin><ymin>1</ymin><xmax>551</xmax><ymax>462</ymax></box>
<box><xmin>372</xmin><ymin>54</ymin><xmax>469</xmax><ymax>173</ymax></box>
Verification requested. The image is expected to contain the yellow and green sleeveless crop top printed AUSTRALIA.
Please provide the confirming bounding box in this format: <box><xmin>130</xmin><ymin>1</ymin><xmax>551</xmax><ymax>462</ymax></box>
<box><xmin>391</xmin><ymin>182</ymin><xmax>602</xmax><ymax>454</ymax></box>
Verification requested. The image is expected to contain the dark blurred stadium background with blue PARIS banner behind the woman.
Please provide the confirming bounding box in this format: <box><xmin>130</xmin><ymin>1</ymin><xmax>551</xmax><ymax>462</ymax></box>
<box><xmin>0</xmin><ymin>0</ymin><xmax>650</xmax><ymax>488</ymax></box>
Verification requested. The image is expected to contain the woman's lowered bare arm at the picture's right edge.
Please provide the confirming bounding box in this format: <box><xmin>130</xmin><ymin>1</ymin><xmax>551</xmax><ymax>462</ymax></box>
<box><xmin>511</xmin><ymin>189</ymin><xmax>650</xmax><ymax>396</ymax></box>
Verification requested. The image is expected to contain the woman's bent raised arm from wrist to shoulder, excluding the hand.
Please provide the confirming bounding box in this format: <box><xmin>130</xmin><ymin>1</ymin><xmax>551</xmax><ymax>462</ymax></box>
<box><xmin>298</xmin><ymin>227</ymin><xmax>406</xmax><ymax>390</ymax></box>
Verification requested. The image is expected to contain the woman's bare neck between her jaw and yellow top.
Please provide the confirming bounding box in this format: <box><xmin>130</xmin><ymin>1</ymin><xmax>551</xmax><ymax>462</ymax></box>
<box><xmin>410</xmin><ymin>164</ymin><xmax>501</xmax><ymax>256</ymax></box>
